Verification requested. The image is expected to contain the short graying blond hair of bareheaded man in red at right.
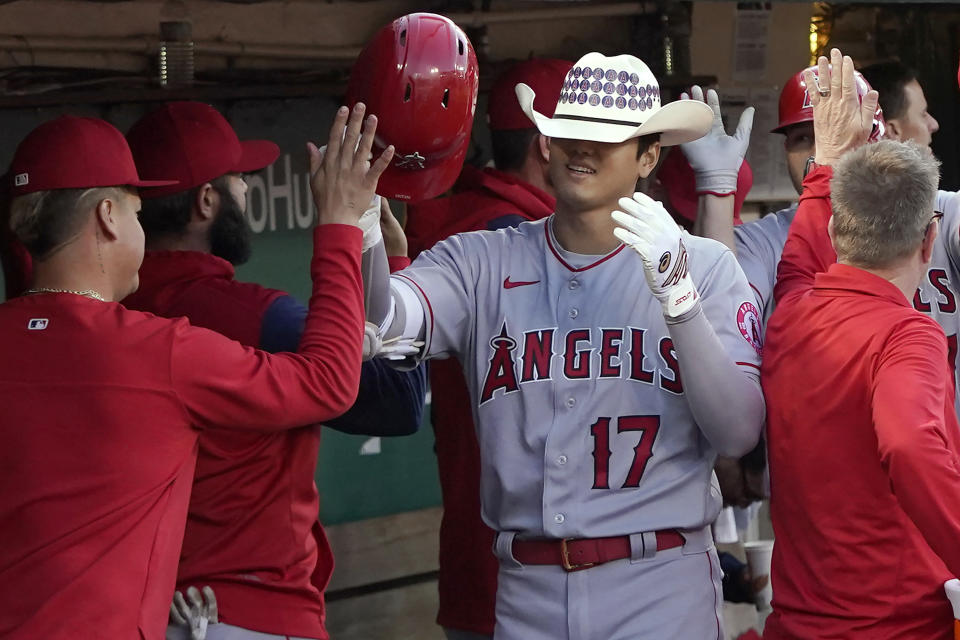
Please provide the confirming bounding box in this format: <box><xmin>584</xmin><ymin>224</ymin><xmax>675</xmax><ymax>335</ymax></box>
<box><xmin>830</xmin><ymin>140</ymin><xmax>940</xmax><ymax>269</ymax></box>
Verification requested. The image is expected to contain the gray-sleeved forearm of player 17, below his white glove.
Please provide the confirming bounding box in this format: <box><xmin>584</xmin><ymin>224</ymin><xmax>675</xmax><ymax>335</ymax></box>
<box><xmin>667</xmin><ymin>308</ymin><xmax>765</xmax><ymax>457</ymax></box>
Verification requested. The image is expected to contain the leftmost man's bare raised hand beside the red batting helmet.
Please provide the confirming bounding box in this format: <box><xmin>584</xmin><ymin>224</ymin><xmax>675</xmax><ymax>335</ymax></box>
<box><xmin>307</xmin><ymin>102</ymin><xmax>394</xmax><ymax>226</ymax></box>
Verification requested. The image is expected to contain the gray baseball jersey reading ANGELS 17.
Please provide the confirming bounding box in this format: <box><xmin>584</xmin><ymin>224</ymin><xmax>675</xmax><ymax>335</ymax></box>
<box><xmin>394</xmin><ymin>219</ymin><xmax>761</xmax><ymax>538</ymax></box>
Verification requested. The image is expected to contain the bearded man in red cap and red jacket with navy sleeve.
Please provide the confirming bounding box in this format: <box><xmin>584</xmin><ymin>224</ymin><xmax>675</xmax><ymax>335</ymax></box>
<box><xmin>123</xmin><ymin>102</ymin><xmax>426</xmax><ymax>640</ymax></box>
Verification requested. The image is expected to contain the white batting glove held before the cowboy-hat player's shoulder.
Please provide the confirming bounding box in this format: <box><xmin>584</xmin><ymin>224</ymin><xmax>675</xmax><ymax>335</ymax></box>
<box><xmin>610</xmin><ymin>192</ymin><xmax>700</xmax><ymax>318</ymax></box>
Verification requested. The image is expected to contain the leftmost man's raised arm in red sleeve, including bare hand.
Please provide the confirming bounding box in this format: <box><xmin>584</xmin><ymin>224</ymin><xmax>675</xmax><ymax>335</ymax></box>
<box><xmin>170</xmin><ymin>103</ymin><xmax>393</xmax><ymax>429</ymax></box>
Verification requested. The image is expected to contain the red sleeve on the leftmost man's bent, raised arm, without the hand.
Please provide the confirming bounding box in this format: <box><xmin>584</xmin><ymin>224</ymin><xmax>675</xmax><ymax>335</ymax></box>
<box><xmin>170</xmin><ymin>225</ymin><xmax>363</xmax><ymax>431</ymax></box>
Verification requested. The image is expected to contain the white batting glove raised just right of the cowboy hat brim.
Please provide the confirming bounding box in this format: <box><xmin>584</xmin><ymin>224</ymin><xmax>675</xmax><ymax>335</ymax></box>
<box><xmin>680</xmin><ymin>85</ymin><xmax>754</xmax><ymax>195</ymax></box>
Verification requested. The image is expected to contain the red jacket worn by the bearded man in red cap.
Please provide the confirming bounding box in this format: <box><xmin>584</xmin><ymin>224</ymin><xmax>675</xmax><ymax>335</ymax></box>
<box><xmin>123</xmin><ymin>251</ymin><xmax>333</xmax><ymax>638</ymax></box>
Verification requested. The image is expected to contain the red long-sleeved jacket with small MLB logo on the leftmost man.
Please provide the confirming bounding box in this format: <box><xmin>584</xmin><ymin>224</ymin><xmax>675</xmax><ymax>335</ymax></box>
<box><xmin>0</xmin><ymin>225</ymin><xmax>363</xmax><ymax>640</ymax></box>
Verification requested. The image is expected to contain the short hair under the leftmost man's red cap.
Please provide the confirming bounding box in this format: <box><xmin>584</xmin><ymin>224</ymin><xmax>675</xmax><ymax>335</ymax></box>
<box><xmin>10</xmin><ymin>187</ymin><xmax>122</xmax><ymax>261</ymax></box>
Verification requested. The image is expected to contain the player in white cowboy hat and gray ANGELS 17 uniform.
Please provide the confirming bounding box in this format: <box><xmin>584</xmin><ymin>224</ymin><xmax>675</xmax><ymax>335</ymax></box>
<box><xmin>364</xmin><ymin>53</ymin><xmax>764</xmax><ymax>640</ymax></box>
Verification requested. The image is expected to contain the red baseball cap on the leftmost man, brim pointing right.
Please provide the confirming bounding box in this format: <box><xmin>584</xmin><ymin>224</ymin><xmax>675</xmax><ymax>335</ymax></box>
<box><xmin>7</xmin><ymin>116</ymin><xmax>176</xmax><ymax>197</ymax></box>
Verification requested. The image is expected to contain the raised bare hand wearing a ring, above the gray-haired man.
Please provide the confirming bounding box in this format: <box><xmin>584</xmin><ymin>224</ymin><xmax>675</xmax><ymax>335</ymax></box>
<box><xmin>803</xmin><ymin>48</ymin><xmax>879</xmax><ymax>164</ymax></box>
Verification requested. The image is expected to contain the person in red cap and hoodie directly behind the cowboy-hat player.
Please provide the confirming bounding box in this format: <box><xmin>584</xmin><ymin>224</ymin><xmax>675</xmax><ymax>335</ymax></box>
<box><xmin>406</xmin><ymin>59</ymin><xmax>573</xmax><ymax>640</ymax></box>
